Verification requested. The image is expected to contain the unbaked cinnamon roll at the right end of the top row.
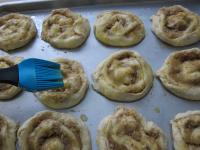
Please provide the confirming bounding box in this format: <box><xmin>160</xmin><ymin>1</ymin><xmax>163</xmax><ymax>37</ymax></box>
<box><xmin>152</xmin><ymin>5</ymin><xmax>200</xmax><ymax>46</ymax></box>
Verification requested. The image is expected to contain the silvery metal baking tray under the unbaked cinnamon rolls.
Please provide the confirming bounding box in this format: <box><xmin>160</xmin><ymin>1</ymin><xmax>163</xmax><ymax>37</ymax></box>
<box><xmin>0</xmin><ymin>0</ymin><xmax>200</xmax><ymax>150</ymax></box>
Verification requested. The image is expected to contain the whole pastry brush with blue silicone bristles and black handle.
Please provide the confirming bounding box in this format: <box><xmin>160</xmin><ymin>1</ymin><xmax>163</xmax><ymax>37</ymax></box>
<box><xmin>0</xmin><ymin>58</ymin><xmax>64</xmax><ymax>92</ymax></box>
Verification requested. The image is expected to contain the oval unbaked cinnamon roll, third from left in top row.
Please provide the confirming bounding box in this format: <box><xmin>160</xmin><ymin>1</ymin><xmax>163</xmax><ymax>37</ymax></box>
<box><xmin>94</xmin><ymin>10</ymin><xmax>145</xmax><ymax>46</ymax></box>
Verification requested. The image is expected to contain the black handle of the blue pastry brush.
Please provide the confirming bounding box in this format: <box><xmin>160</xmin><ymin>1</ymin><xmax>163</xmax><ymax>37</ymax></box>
<box><xmin>0</xmin><ymin>65</ymin><xmax>19</xmax><ymax>86</ymax></box>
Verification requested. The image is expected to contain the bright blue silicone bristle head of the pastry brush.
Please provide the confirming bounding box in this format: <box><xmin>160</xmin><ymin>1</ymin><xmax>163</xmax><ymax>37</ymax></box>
<box><xmin>18</xmin><ymin>58</ymin><xmax>64</xmax><ymax>91</ymax></box>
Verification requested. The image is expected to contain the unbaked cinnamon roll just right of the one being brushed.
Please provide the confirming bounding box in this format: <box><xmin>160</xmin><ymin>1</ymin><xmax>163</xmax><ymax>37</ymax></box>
<box><xmin>93</xmin><ymin>50</ymin><xmax>153</xmax><ymax>101</ymax></box>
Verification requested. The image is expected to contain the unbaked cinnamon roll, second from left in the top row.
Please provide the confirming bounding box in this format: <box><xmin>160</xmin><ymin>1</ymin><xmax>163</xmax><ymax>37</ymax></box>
<box><xmin>42</xmin><ymin>8</ymin><xmax>90</xmax><ymax>49</ymax></box>
